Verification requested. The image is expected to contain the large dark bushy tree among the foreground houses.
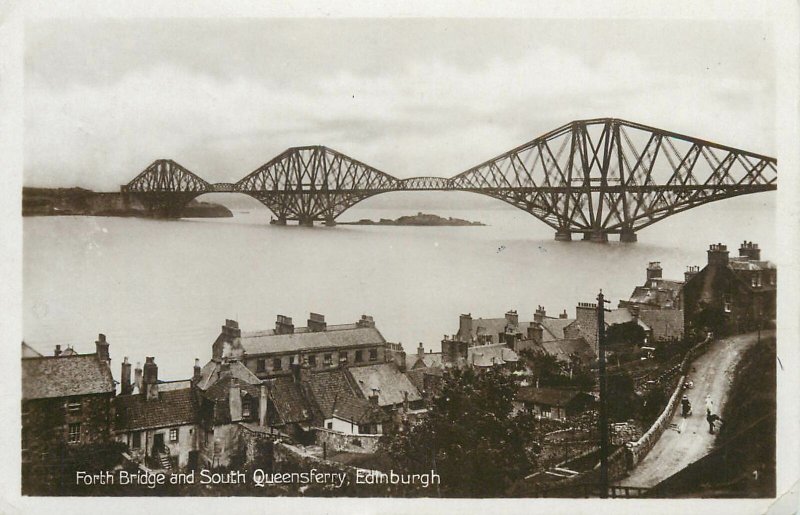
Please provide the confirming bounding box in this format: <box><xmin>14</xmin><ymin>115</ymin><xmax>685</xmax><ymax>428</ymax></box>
<box><xmin>382</xmin><ymin>369</ymin><xmax>535</xmax><ymax>497</ymax></box>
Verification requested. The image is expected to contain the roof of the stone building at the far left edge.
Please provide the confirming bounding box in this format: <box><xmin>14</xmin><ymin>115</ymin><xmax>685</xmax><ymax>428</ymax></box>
<box><xmin>22</xmin><ymin>354</ymin><xmax>115</xmax><ymax>400</ymax></box>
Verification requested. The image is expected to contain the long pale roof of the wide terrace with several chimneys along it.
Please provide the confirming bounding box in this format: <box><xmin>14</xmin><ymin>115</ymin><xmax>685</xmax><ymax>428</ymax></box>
<box><xmin>241</xmin><ymin>324</ymin><xmax>386</xmax><ymax>356</ymax></box>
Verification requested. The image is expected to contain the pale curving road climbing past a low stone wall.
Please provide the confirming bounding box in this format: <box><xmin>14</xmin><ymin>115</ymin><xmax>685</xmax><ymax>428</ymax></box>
<box><xmin>618</xmin><ymin>330</ymin><xmax>775</xmax><ymax>488</ymax></box>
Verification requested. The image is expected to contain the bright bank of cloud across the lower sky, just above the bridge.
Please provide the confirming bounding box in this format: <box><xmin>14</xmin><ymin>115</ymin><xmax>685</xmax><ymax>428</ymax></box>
<box><xmin>25</xmin><ymin>46</ymin><xmax>775</xmax><ymax>190</ymax></box>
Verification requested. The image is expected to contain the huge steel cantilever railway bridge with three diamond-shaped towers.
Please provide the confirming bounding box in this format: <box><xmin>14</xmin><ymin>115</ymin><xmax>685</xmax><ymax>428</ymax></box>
<box><xmin>121</xmin><ymin>118</ymin><xmax>777</xmax><ymax>242</ymax></box>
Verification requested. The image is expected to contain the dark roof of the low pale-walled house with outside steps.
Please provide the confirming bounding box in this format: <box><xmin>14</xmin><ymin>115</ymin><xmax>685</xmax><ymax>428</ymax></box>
<box><xmin>112</xmin><ymin>388</ymin><xmax>198</xmax><ymax>431</ymax></box>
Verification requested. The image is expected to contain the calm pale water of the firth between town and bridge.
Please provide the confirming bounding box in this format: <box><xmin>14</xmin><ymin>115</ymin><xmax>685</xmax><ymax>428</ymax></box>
<box><xmin>23</xmin><ymin>193</ymin><xmax>776</xmax><ymax>379</ymax></box>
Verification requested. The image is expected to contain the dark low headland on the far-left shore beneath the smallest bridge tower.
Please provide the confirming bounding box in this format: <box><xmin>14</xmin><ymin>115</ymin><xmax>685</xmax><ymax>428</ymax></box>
<box><xmin>22</xmin><ymin>187</ymin><xmax>233</xmax><ymax>218</ymax></box>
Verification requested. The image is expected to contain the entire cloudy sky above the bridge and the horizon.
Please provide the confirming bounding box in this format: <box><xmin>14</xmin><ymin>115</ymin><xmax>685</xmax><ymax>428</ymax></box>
<box><xmin>23</xmin><ymin>18</ymin><xmax>776</xmax><ymax>191</ymax></box>
